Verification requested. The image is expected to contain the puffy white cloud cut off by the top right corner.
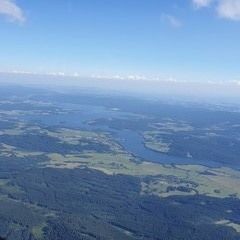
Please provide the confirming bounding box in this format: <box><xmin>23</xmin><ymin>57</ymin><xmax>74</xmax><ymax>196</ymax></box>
<box><xmin>217</xmin><ymin>0</ymin><xmax>240</xmax><ymax>21</ymax></box>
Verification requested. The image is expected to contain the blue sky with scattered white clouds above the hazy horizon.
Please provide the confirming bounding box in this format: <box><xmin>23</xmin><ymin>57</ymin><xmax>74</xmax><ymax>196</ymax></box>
<box><xmin>0</xmin><ymin>0</ymin><xmax>240</xmax><ymax>81</ymax></box>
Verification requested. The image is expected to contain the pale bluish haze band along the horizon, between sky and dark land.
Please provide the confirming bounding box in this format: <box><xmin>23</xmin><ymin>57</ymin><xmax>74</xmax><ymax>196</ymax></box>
<box><xmin>0</xmin><ymin>73</ymin><xmax>240</xmax><ymax>104</ymax></box>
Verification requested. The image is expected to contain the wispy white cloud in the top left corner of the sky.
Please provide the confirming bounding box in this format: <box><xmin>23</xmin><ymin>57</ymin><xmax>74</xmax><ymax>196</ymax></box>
<box><xmin>0</xmin><ymin>0</ymin><xmax>25</xmax><ymax>23</ymax></box>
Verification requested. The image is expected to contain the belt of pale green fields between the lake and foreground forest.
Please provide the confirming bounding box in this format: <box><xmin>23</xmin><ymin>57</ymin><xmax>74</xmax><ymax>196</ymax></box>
<box><xmin>1</xmin><ymin>126</ymin><xmax>240</xmax><ymax>201</ymax></box>
